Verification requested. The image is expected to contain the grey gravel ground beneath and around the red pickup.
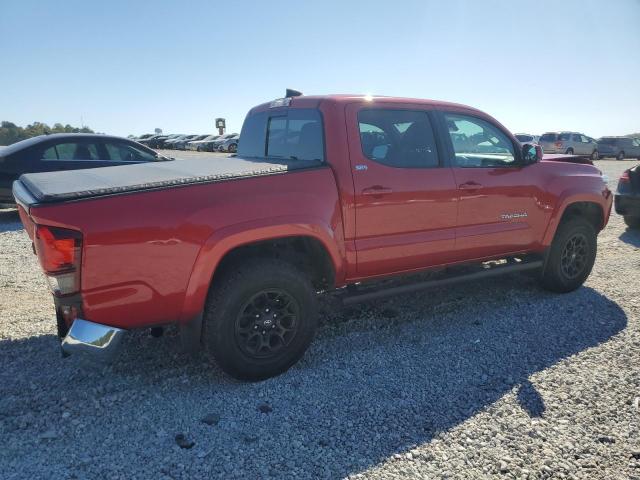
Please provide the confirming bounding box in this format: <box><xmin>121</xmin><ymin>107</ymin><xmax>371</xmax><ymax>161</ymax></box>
<box><xmin>0</xmin><ymin>161</ymin><xmax>640</xmax><ymax>479</ymax></box>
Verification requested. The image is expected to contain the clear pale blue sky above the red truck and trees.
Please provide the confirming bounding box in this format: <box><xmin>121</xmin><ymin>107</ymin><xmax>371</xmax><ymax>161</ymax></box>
<box><xmin>0</xmin><ymin>0</ymin><xmax>640</xmax><ymax>136</ymax></box>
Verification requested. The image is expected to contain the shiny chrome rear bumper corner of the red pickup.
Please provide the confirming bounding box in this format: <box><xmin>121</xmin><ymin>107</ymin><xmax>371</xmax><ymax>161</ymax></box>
<box><xmin>61</xmin><ymin>318</ymin><xmax>127</xmax><ymax>362</ymax></box>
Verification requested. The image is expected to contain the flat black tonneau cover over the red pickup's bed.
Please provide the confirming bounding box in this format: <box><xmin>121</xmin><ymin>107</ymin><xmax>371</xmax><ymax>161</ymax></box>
<box><xmin>14</xmin><ymin>157</ymin><xmax>322</xmax><ymax>203</ymax></box>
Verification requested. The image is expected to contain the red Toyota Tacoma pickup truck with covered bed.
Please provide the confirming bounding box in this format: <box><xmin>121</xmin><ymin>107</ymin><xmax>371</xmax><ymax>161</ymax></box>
<box><xmin>13</xmin><ymin>94</ymin><xmax>612</xmax><ymax>380</ymax></box>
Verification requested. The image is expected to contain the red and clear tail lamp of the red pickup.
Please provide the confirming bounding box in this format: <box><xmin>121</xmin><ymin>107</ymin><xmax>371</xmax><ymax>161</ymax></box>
<box><xmin>34</xmin><ymin>225</ymin><xmax>82</xmax><ymax>295</ymax></box>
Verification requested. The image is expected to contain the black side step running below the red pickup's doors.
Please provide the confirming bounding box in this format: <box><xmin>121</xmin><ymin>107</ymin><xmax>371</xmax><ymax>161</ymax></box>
<box><xmin>342</xmin><ymin>260</ymin><xmax>544</xmax><ymax>305</ymax></box>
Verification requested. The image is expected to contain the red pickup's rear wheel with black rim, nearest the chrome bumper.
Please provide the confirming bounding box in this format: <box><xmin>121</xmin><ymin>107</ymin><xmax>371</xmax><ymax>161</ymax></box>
<box><xmin>203</xmin><ymin>259</ymin><xmax>318</xmax><ymax>381</ymax></box>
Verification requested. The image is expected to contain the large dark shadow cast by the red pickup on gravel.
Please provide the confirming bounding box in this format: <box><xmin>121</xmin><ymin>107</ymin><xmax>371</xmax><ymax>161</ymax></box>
<box><xmin>0</xmin><ymin>277</ymin><xmax>627</xmax><ymax>478</ymax></box>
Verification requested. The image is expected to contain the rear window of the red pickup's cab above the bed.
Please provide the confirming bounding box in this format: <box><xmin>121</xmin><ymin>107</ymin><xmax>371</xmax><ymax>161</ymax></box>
<box><xmin>238</xmin><ymin>108</ymin><xmax>325</xmax><ymax>165</ymax></box>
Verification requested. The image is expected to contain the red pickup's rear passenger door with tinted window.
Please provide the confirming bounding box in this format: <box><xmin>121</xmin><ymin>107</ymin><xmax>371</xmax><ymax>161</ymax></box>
<box><xmin>346</xmin><ymin>104</ymin><xmax>457</xmax><ymax>277</ymax></box>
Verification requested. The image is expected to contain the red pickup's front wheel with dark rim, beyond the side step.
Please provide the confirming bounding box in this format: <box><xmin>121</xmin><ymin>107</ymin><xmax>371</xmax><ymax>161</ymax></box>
<box><xmin>541</xmin><ymin>217</ymin><xmax>597</xmax><ymax>293</ymax></box>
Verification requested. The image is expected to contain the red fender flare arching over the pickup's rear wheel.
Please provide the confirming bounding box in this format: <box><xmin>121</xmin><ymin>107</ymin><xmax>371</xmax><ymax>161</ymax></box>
<box><xmin>179</xmin><ymin>216</ymin><xmax>345</xmax><ymax>324</ymax></box>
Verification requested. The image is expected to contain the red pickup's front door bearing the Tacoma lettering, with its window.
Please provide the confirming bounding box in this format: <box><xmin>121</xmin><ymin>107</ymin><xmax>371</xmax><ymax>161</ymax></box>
<box><xmin>440</xmin><ymin>112</ymin><xmax>545</xmax><ymax>260</ymax></box>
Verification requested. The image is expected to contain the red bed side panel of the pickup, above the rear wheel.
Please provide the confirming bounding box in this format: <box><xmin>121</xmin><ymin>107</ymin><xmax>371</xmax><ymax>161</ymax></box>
<box><xmin>30</xmin><ymin>167</ymin><xmax>343</xmax><ymax>328</ymax></box>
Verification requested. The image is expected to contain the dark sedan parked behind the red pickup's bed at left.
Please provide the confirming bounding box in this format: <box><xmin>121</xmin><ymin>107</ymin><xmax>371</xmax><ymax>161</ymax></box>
<box><xmin>0</xmin><ymin>133</ymin><xmax>170</xmax><ymax>204</ymax></box>
